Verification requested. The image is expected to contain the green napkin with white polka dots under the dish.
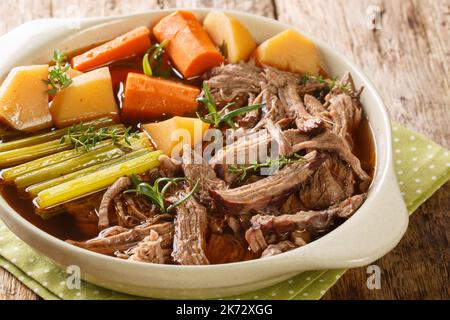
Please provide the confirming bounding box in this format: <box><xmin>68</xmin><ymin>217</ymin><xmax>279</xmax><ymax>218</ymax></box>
<box><xmin>0</xmin><ymin>125</ymin><xmax>450</xmax><ymax>300</ymax></box>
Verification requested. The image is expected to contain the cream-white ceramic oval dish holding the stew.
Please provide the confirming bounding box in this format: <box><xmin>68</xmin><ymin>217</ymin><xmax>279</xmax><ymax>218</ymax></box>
<box><xmin>0</xmin><ymin>9</ymin><xmax>408</xmax><ymax>298</ymax></box>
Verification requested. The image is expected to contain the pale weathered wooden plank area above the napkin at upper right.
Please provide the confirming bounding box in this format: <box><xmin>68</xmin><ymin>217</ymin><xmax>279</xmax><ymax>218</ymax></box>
<box><xmin>276</xmin><ymin>0</ymin><xmax>450</xmax><ymax>148</ymax></box>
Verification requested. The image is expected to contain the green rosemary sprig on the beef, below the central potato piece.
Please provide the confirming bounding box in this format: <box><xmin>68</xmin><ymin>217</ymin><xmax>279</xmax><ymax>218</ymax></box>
<box><xmin>125</xmin><ymin>175</ymin><xmax>199</xmax><ymax>213</ymax></box>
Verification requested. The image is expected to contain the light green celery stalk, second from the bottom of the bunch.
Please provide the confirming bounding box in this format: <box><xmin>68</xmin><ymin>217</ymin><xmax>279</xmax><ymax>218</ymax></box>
<box><xmin>25</xmin><ymin>148</ymin><xmax>152</xmax><ymax>197</ymax></box>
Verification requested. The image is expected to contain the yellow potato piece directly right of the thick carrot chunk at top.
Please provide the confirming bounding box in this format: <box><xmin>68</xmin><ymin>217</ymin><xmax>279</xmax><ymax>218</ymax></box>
<box><xmin>203</xmin><ymin>11</ymin><xmax>256</xmax><ymax>63</ymax></box>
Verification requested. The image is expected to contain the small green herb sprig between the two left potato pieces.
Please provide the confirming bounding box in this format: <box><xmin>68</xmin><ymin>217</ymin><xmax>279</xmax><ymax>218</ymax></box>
<box><xmin>42</xmin><ymin>50</ymin><xmax>72</xmax><ymax>95</ymax></box>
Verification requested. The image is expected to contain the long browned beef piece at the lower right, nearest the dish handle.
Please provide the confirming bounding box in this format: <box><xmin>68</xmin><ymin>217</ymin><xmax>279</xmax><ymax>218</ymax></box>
<box><xmin>245</xmin><ymin>194</ymin><xmax>367</xmax><ymax>254</ymax></box>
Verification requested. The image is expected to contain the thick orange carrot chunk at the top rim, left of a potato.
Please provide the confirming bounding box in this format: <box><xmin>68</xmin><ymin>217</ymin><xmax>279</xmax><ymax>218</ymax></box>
<box><xmin>153</xmin><ymin>11</ymin><xmax>224</xmax><ymax>79</ymax></box>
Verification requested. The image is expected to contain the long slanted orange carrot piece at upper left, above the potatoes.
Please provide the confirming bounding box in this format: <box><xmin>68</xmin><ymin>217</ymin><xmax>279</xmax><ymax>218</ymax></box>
<box><xmin>72</xmin><ymin>27</ymin><xmax>151</xmax><ymax>72</ymax></box>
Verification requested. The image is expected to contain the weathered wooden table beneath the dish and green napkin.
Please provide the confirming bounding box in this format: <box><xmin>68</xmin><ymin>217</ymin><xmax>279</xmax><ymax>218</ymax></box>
<box><xmin>0</xmin><ymin>0</ymin><xmax>450</xmax><ymax>299</ymax></box>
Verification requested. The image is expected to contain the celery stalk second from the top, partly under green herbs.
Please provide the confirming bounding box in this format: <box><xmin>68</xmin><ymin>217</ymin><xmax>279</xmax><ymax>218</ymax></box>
<box><xmin>0</xmin><ymin>125</ymin><xmax>125</xmax><ymax>170</ymax></box>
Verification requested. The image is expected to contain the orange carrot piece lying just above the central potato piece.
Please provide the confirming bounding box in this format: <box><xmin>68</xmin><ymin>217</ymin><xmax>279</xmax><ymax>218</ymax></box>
<box><xmin>122</xmin><ymin>73</ymin><xmax>200</xmax><ymax>121</ymax></box>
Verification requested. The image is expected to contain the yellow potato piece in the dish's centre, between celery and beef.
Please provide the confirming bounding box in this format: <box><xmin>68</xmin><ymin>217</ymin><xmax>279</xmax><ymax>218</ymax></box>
<box><xmin>142</xmin><ymin>117</ymin><xmax>210</xmax><ymax>156</ymax></box>
